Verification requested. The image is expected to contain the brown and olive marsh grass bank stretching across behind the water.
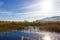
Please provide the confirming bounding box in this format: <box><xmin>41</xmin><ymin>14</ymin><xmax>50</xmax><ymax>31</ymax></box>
<box><xmin>0</xmin><ymin>21</ymin><xmax>60</xmax><ymax>32</ymax></box>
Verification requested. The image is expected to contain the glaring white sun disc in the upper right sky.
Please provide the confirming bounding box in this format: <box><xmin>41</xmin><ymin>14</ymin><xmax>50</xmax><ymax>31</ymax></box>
<box><xmin>41</xmin><ymin>0</ymin><xmax>53</xmax><ymax>12</ymax></box>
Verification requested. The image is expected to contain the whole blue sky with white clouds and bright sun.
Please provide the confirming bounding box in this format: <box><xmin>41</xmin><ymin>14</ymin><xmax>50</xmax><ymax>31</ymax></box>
<box><xmin>0</xmin><ymin>0</ymin><xmax>60</xmax><ymax>21</ymax></box>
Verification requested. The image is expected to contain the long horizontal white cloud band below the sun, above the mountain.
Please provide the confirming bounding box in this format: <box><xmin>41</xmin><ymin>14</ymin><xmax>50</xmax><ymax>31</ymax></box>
<box><xmin>25</xmin><ymin>11</ymin><xmax>60</xmax><ymax>17</ymax></box>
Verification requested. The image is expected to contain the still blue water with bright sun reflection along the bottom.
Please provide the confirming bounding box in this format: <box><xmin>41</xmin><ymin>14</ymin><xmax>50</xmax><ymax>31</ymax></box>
<box><xmin>0</xmin><ymin>27</ymin><xmax>60</xmax><ymax>40</ymax></box>
